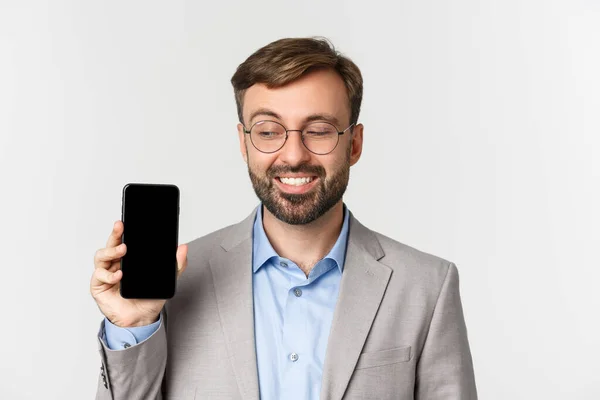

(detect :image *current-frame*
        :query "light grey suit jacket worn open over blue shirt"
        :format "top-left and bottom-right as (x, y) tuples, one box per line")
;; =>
(96, 211), (477, 400)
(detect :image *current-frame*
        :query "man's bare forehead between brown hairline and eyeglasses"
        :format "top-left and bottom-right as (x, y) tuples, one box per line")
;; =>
(243, 69), (350, 124)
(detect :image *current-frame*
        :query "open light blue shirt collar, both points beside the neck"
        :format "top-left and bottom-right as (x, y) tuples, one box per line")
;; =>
(252, 203), (350, 273)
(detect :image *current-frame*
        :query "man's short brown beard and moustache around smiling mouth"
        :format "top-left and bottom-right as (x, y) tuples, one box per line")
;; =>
(248, 148), (352, 225)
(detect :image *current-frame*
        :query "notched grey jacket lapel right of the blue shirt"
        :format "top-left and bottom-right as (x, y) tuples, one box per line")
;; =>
(320, 214), (392, 400)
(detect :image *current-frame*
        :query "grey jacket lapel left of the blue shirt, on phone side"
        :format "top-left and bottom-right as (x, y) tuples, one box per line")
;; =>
(210, 210), (259, 400)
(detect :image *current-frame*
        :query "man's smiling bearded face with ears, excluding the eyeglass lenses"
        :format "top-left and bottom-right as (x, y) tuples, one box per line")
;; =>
(238, 70), (363, 225)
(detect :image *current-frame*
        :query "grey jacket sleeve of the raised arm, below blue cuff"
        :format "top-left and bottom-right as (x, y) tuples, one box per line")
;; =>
(96, 307), (167, 400)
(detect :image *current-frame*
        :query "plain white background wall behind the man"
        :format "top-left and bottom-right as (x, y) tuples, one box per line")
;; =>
(0, 0), (600, 400)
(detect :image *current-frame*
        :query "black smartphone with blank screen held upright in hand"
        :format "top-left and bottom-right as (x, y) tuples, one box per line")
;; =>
(120, 183), (179, 299)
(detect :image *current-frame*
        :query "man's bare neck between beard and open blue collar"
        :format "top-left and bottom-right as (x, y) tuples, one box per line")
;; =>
(263, 200), (344, 277)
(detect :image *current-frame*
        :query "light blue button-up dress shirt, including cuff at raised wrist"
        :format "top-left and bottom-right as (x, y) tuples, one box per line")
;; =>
(104, 204), (349, 400)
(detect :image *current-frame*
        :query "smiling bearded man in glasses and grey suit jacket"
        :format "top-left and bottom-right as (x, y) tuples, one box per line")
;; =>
(91, 39), (477, 400)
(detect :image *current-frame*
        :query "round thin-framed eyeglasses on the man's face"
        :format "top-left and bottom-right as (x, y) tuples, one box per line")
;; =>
(244, 121), (354, 155)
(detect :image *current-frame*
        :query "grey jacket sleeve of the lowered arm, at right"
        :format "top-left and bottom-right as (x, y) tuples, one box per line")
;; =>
(415, 263), (477, 400)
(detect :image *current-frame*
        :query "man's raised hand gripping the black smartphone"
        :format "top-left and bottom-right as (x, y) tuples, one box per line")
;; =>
(90, 221), (188, 327)
